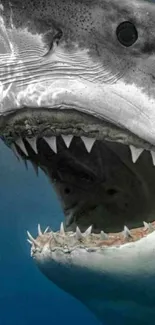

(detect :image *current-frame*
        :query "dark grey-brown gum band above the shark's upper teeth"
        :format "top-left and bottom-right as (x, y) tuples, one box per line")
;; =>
(0, 105), (155, 152)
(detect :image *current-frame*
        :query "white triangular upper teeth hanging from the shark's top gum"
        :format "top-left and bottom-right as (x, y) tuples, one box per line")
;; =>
(12, 135), (155, 165)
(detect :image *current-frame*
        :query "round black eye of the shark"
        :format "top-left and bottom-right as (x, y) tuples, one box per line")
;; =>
(116, 21), (138, 47)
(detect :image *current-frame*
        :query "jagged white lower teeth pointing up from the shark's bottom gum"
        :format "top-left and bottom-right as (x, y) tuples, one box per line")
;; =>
(27, 221), (154, 249)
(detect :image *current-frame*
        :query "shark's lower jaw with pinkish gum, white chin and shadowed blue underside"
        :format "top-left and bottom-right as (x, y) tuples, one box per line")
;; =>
(28, 220), (155, 325)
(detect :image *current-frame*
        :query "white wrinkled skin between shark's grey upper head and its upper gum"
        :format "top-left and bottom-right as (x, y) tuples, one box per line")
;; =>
(0, 31), (155, 149)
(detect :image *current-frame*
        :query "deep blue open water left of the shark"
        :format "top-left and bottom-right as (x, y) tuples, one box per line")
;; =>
(0, 143), (99, 325)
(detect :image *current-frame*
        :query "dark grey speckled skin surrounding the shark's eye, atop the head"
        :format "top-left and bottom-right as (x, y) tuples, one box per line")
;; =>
(1, 0), (155, 98)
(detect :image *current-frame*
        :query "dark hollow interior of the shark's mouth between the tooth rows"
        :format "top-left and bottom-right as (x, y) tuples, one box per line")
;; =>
(10, 135), (155, 238)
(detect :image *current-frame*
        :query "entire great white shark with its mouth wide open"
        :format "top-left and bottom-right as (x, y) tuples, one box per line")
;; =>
(0, 0), (155, 325)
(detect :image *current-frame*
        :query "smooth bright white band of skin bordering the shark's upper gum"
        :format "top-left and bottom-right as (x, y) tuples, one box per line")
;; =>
(0, 67), (155, 149)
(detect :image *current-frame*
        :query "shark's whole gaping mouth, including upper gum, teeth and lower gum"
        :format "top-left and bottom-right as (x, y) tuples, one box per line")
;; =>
(1, 109), (155, 247)
